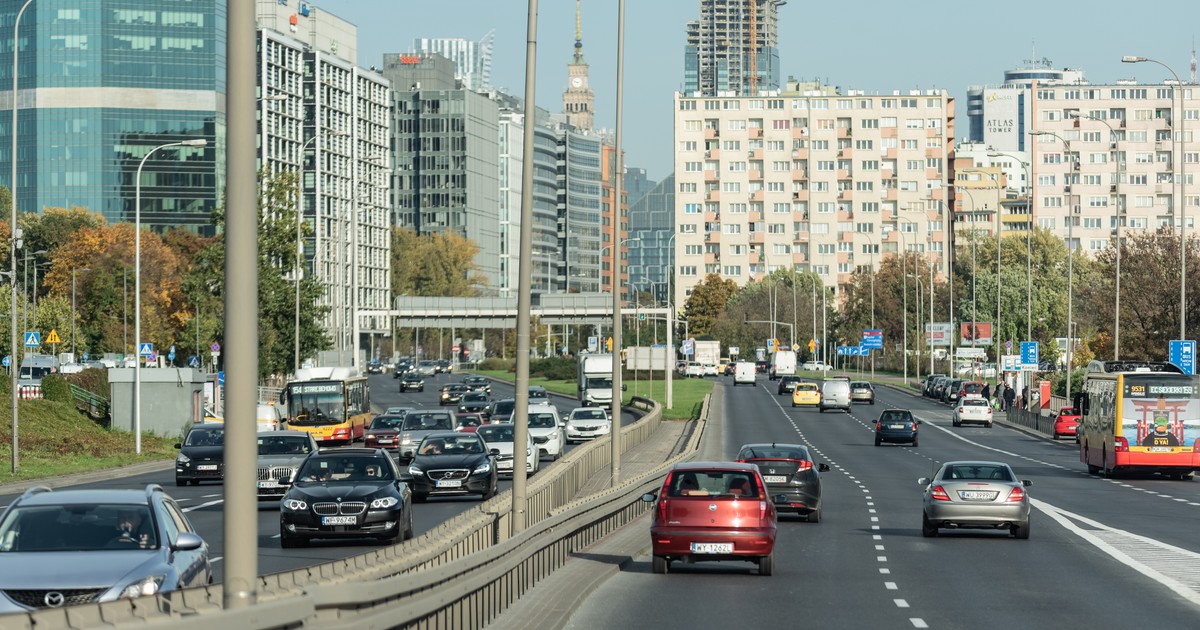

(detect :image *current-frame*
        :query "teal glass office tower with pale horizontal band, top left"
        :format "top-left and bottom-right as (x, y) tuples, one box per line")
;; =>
(0, 0), (227, 234)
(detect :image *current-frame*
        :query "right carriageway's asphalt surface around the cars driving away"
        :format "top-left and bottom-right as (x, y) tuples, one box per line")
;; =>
(568, 377), (1200, 630)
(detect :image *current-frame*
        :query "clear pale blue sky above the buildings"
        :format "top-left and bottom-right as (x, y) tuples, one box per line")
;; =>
(316, 0), (1200, 180)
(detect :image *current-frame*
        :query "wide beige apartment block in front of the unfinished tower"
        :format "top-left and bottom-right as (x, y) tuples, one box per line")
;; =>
(674, 83), (954, 305)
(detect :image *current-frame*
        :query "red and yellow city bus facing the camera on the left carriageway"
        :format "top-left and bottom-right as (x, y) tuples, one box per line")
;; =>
(283, 367), (371, 444)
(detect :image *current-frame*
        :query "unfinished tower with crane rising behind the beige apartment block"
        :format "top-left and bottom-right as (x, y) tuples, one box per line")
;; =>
(683, 0), (786, 96)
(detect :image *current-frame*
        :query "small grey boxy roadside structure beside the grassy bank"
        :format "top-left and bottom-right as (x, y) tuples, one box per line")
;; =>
(108, 367), (208, 436)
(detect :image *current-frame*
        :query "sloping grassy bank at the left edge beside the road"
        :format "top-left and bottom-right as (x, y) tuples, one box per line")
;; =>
(0, 400), (178, 484)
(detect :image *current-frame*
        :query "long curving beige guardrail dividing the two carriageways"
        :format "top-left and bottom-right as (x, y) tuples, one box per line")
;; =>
(14, 397), (709, 630)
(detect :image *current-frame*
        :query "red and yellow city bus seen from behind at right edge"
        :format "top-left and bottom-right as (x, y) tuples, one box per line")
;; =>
(1072, 361), (1200, 479)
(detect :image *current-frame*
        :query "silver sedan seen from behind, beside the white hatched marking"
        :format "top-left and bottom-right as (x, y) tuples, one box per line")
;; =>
(917, 461), (1032, 539)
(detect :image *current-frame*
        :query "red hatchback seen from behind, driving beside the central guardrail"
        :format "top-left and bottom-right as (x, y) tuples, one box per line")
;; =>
(642, 462), (776, 575)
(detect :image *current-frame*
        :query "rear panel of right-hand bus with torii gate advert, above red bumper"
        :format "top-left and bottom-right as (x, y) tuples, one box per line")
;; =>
(1121, 374), (1200, 449)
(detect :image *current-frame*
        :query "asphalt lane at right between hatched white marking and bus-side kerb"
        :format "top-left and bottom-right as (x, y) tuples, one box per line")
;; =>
(873, 392), (1200, 552)
